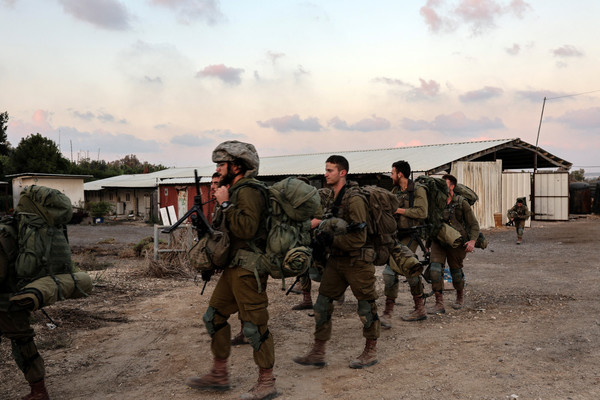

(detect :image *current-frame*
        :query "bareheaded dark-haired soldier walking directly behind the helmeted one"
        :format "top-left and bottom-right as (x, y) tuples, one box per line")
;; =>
(294, 155), (380, 368)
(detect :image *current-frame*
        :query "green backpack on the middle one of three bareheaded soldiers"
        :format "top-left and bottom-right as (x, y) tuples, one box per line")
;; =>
(415, 175), (449, 238)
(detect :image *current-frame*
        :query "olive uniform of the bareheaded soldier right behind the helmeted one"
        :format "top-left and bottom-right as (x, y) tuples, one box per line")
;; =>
(314, 183), (380, 341)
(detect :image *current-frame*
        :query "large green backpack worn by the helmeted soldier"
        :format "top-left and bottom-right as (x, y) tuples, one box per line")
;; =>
(232, 178), (321, 290)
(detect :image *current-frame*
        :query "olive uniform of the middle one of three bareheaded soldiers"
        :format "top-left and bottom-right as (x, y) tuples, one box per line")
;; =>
(383, 180), (427, 300)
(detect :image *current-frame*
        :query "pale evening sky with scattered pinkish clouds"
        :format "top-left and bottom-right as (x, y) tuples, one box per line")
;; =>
(0, 0), (600, 172)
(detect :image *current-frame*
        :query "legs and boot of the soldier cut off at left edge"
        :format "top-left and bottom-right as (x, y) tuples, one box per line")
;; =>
(0, 300), (50, 400)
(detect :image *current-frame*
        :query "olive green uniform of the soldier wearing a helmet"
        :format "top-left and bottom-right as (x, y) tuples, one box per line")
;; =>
(203, 178), (275, 369)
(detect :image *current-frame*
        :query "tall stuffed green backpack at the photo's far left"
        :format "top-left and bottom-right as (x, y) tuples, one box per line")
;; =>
(15, 185), (73, 288)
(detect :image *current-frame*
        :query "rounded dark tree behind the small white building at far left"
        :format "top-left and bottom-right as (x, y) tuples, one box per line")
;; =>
(10, 133), (71, 174)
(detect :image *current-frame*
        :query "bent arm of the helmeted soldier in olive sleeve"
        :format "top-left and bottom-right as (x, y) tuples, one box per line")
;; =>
(225, 187), (265, 240)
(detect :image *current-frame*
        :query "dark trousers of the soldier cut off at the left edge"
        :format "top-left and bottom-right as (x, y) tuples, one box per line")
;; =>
(0, 310), (46, 383)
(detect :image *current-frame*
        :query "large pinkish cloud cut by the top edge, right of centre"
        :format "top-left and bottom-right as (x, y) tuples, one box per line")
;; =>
(420, 0), (531, 35)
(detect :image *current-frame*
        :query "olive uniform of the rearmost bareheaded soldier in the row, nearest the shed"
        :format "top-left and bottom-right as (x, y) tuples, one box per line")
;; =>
(430, 194), (479, 292)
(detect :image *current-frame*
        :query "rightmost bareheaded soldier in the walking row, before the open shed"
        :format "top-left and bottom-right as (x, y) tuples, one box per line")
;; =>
(429, 174), (479, 314)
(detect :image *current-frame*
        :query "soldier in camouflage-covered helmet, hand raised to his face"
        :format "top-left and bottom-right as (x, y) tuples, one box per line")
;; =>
(186, 141), (277, 399)
